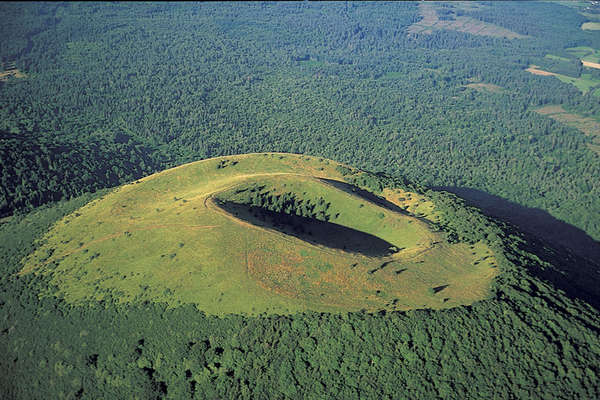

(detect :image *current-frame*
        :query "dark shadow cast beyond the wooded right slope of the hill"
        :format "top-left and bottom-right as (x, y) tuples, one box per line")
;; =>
(435, 187), (600, 309)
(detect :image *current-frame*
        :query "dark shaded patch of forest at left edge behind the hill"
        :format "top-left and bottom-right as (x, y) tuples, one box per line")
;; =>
(0, 131), (164, 216)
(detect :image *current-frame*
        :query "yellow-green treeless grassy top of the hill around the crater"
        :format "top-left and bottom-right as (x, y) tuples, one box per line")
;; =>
(21, 153), (498, 315)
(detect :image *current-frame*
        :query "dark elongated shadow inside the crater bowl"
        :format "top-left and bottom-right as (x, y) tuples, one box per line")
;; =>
(215, 200), (396, 257)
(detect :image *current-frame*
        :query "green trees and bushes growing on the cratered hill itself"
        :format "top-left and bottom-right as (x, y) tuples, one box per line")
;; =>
(0, 155), (600, 399)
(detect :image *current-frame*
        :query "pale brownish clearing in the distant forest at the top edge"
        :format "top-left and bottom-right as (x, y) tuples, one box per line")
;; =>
(408, 3), (525, 39)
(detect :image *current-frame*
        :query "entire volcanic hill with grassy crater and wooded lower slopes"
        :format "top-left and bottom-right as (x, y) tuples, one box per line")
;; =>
(0, 153), (600, 399)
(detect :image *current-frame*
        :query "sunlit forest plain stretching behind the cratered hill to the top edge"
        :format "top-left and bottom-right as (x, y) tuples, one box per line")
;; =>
(0, 2), (600, 239)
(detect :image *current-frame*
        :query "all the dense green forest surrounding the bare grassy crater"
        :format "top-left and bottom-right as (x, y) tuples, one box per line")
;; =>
(0, 2), (600, 399)
